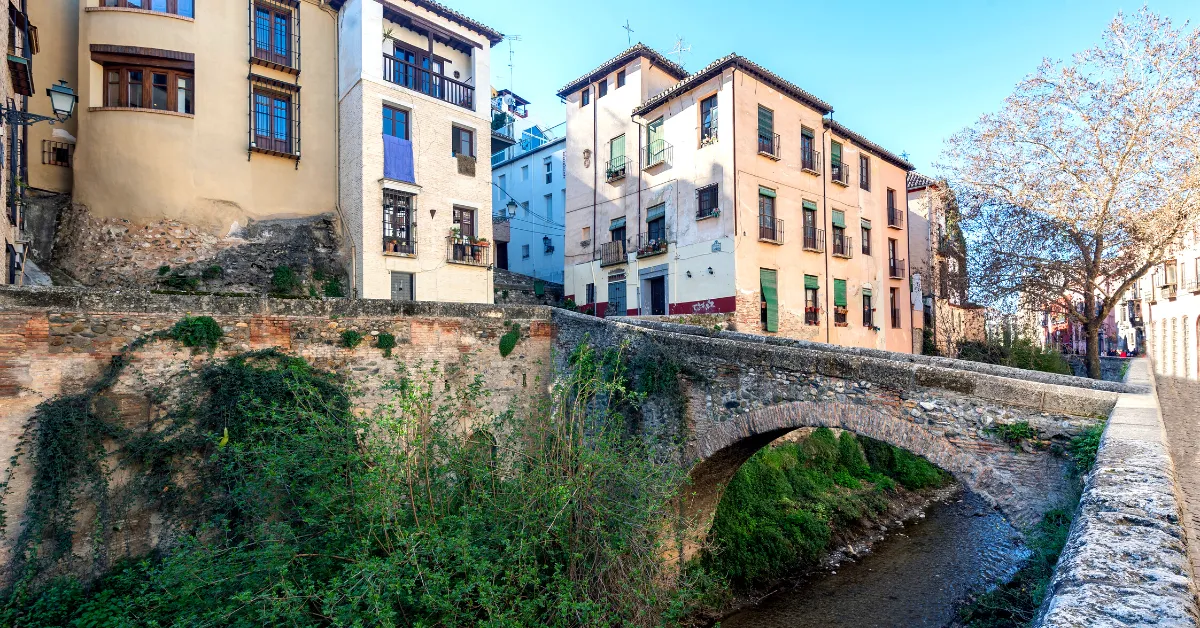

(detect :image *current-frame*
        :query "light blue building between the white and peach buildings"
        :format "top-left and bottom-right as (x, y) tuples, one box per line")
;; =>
(492, 115), (566, 283)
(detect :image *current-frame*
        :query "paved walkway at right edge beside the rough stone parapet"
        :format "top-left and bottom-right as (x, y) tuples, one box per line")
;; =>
(1154, 375), (1200, 583)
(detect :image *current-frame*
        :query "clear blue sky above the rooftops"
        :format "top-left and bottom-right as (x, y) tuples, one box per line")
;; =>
(444, 0), (1200, 172)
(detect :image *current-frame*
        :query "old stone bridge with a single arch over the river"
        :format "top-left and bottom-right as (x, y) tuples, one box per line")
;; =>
(554, 311), (1127, 554)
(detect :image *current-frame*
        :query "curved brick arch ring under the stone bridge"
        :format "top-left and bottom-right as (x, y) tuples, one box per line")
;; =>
(683, 401), (1032, 556)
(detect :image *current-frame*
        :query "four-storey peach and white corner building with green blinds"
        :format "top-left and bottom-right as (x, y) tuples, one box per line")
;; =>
(559, 44), (913, 352)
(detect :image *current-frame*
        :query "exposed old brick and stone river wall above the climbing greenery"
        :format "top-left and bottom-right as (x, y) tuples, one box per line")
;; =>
(0, 288), (552, 578)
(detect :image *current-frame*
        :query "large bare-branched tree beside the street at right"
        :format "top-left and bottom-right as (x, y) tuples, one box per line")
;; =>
(942, 8), (1200, 378)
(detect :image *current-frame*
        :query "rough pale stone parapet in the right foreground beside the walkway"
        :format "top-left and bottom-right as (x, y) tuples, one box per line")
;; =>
(1036, 359), (1200, 627)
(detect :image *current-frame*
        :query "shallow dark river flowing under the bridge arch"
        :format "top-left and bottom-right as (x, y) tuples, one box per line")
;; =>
(720, 492), (1026, 628)
